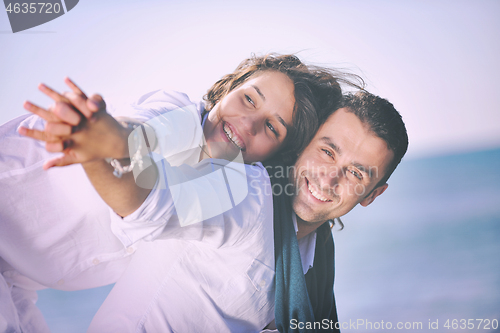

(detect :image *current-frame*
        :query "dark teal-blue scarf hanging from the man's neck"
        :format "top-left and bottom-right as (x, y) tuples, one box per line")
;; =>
(266, 161), (339, 333)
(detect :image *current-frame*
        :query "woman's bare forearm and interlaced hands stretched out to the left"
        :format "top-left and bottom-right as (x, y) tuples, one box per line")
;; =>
(20, 79), (157, 216)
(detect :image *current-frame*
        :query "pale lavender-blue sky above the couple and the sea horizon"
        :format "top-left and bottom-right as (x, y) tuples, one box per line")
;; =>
(0, 0), (500, 157)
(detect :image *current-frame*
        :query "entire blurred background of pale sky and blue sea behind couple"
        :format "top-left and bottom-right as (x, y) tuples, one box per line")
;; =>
(0, 0), (500, 333)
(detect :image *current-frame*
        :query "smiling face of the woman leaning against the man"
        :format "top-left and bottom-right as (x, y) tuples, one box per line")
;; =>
(203, 71), (295, 163)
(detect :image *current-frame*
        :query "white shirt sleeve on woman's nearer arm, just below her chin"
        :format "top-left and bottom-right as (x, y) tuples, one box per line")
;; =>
(111, 159), (270, 246)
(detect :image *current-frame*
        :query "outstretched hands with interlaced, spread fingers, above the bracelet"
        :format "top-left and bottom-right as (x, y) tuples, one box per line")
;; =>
(19, 78), (129, 169)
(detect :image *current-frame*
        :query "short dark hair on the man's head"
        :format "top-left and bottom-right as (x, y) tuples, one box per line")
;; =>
(340, 90), (408, 188)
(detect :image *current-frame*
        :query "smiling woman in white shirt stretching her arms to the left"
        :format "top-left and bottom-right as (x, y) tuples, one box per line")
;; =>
(0, 55), (362, 331)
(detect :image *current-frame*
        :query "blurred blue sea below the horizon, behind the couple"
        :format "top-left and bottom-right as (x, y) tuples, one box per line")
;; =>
(37, 149), (500, 333)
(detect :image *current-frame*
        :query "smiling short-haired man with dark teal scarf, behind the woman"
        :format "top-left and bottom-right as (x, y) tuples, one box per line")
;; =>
(270, 92), (408, 332)
